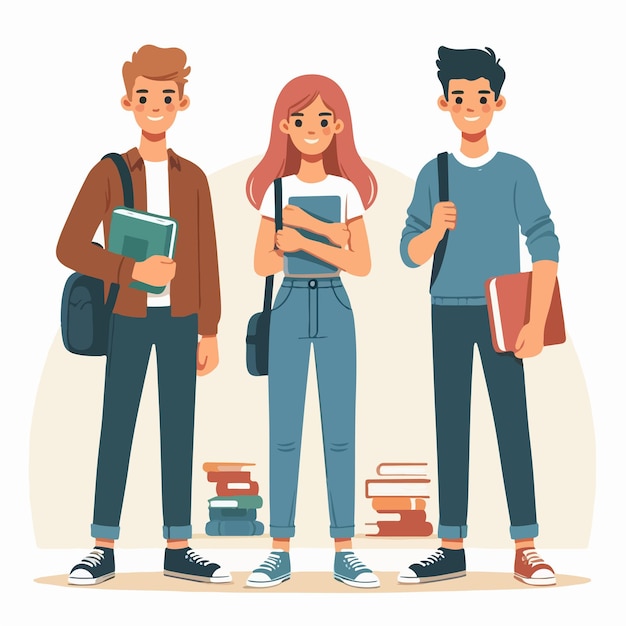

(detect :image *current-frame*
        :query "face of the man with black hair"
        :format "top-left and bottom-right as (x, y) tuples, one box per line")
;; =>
(437, 78), (506, 135)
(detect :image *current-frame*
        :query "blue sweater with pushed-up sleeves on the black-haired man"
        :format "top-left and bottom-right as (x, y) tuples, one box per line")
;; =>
(400, 152), (559, 305)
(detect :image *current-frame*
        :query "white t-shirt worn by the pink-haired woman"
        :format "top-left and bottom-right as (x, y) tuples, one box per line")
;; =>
(259, 174), (365, 222)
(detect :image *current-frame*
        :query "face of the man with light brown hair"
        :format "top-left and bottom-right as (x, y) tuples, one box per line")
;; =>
(122, 76), (189, 135)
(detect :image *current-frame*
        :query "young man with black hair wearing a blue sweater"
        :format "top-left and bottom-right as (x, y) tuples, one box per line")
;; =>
(398, 46), (559, 585)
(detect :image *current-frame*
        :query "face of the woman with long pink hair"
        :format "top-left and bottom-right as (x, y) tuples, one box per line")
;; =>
(279, 96), (343, 156)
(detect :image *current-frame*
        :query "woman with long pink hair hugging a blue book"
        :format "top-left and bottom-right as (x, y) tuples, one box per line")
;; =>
(246, 74), (380, 587)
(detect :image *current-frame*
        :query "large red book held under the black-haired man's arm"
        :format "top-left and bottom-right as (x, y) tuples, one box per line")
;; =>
(485, 272), (565, 352)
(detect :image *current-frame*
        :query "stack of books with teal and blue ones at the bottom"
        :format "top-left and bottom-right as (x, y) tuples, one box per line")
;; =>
(202, 461), (264, 537)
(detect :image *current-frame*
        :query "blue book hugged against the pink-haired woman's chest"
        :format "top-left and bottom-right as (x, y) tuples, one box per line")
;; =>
(283, 196), (341, 276)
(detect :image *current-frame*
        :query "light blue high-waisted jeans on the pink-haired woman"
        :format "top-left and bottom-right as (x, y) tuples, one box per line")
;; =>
(268, 278), (356, 538)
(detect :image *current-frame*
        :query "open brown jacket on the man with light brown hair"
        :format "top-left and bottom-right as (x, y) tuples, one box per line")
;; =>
(57, 148), (221, 335)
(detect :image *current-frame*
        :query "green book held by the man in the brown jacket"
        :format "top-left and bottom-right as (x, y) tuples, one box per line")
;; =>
(108, 207), (178, 293)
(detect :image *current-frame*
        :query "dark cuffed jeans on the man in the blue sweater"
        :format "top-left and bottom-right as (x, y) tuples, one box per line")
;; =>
(432, 305), (539, 539)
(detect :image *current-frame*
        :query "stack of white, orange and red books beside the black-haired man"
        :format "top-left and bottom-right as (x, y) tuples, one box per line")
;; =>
(365, 462), (433, 537)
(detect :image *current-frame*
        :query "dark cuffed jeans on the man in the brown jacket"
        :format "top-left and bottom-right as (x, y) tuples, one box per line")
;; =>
(91, 307), (198, 539)
